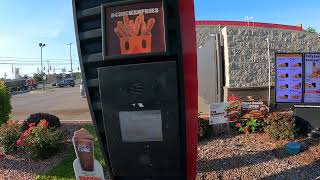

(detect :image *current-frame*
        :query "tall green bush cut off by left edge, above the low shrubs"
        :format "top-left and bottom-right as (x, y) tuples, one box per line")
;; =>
(0, 81), (12, 125)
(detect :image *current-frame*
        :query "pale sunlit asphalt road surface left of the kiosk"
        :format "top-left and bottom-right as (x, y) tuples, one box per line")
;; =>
(11, 87), (91, 120)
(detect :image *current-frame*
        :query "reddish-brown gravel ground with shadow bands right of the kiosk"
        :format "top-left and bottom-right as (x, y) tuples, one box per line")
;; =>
(197, 134), (320, 180)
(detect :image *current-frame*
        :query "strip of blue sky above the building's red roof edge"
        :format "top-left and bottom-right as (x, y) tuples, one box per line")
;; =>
(194, 0), (320, 29)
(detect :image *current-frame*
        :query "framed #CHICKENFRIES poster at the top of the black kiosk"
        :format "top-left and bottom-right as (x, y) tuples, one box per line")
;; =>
(103, 1), (166, 56)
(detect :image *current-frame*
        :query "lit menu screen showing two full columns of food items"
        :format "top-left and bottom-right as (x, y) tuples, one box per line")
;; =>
(276, 54), (302, 103)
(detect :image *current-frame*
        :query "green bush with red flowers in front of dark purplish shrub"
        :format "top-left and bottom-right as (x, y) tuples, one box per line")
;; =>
(22, 126), (64, 159)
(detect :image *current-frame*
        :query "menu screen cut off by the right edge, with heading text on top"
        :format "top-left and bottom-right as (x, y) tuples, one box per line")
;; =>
(304, 54), (320, 103)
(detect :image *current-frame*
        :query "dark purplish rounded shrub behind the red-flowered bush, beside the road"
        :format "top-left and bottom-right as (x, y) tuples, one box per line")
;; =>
(22, 113), (61, 130)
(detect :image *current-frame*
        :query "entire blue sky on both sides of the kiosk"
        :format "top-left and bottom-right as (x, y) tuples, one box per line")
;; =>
(0, 0), (320, 78)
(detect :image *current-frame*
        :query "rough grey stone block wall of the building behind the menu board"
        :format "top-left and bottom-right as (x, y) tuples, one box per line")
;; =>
(222, 27), (320, 87)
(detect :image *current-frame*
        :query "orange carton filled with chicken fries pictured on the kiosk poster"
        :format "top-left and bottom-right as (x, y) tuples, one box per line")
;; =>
(114, 14), (155, 54)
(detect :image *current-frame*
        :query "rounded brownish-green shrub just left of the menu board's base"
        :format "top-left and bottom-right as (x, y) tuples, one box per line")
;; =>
(265, 112), (295, 140)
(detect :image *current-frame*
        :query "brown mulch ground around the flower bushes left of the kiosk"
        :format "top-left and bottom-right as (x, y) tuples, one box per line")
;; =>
(0, 125), (79, 180)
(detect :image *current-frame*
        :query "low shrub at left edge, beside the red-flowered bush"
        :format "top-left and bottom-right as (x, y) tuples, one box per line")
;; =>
(0, 121), (21, 153)
